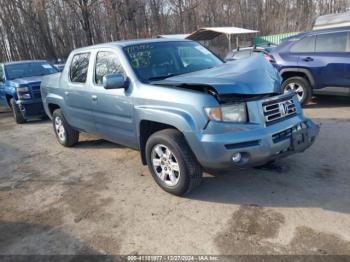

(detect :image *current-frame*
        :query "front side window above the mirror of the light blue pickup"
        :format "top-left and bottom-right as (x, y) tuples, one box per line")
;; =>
(95, 51), (125, 85)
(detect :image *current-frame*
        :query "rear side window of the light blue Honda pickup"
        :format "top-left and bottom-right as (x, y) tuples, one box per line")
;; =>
(69, 53), (90, 83)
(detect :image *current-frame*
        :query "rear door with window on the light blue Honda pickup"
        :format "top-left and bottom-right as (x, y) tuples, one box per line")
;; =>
(63, 52), (96, 133)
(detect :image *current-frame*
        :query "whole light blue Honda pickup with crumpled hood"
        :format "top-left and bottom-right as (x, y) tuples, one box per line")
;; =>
(41, 39), (318, 195)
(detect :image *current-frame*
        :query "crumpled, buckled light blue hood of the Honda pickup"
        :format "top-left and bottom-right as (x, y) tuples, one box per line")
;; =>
(152, 55), (282, 95)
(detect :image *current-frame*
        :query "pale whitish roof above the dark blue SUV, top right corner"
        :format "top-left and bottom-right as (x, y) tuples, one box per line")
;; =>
(313, 12), (350, 30)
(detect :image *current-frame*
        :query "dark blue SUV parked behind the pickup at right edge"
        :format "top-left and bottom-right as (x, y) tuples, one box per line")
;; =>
(271, 27), (350, 104)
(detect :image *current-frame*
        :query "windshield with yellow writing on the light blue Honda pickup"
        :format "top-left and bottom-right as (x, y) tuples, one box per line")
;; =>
(124, 41), (223, 82)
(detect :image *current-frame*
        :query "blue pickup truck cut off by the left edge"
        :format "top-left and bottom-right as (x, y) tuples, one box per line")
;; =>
(0, 61), (57, 124)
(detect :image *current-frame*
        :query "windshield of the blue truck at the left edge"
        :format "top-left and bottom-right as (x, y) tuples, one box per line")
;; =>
(5, 62), (57, 80)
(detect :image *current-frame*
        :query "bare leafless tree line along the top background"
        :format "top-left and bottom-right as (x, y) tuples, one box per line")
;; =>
(0, 0), (350, 61)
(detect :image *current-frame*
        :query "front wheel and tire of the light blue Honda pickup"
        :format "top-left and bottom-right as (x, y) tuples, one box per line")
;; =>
(146, 129), (202, 196)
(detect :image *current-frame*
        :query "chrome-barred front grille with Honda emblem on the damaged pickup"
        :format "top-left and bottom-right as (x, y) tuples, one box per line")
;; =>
(262, 96), (296, 125)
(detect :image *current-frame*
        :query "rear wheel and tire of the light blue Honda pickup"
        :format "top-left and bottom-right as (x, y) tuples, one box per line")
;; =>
(52, 109), (79, 147)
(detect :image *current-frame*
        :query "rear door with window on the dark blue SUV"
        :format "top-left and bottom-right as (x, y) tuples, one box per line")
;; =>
(315, 31), (350, 93)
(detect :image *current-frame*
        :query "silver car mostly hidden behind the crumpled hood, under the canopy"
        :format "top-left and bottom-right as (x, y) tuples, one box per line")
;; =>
(225, 46), (273, 62)
